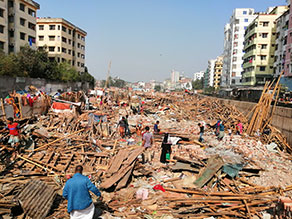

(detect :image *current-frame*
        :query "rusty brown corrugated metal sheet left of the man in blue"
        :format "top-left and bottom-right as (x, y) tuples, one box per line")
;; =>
(15, 180), (56, 219)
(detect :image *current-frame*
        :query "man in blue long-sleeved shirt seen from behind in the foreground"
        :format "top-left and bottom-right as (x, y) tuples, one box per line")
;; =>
(63, 165), (101, 219)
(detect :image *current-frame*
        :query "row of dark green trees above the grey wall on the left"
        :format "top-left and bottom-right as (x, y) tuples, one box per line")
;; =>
(0, 46), (95, 85)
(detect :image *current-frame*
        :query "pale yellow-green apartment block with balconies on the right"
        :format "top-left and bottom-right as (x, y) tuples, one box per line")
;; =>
(242, 6), (288, 86)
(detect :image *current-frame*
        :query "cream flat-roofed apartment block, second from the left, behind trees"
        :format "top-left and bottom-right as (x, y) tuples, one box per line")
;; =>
(37, 18), (87, 72)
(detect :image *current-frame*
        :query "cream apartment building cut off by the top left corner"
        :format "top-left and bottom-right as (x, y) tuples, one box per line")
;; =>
(0, 0), (40, 53)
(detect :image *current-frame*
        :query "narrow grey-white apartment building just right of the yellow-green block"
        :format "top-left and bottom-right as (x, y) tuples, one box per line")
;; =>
(274, 10), (289, 77)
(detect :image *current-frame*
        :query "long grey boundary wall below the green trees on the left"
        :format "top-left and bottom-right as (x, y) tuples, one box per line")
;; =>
(0, 76), (91, 98)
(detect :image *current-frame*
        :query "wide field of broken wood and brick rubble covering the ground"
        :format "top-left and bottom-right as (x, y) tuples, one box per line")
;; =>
(0, 84), (292, 219)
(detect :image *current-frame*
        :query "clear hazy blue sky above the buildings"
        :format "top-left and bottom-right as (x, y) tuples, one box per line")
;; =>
(36, 0), (286, 82)
